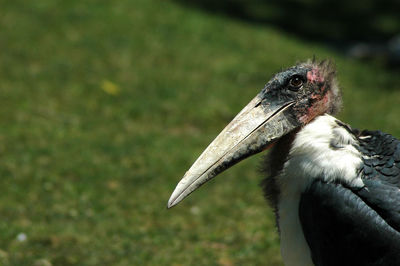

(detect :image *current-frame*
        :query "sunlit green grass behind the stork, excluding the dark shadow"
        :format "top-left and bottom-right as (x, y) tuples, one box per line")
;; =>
(0, 0), (400, 265)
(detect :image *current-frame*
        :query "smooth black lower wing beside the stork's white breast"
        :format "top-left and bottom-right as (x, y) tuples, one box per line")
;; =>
(299, 180), (400, 266)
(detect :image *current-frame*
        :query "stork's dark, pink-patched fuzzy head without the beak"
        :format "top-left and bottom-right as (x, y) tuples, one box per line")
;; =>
(266, 60), (341, 125)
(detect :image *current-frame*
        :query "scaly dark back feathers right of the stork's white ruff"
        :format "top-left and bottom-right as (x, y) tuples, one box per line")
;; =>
(354, 130), (400, 232)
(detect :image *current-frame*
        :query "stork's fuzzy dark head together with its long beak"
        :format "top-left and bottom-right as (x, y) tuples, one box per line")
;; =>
(168, 60), (341, 208)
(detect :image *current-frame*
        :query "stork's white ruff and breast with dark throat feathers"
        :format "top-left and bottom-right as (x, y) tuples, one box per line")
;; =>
(264, 115), (362, 266)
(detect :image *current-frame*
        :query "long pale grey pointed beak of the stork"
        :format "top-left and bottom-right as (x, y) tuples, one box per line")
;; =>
(168, 93), (297, 208)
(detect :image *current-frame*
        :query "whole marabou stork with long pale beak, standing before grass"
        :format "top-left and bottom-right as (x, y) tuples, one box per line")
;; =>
(168, 60), (400, 266)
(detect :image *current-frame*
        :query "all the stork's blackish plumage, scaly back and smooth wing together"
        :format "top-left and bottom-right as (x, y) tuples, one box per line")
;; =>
(299, 127), (400, 266)
